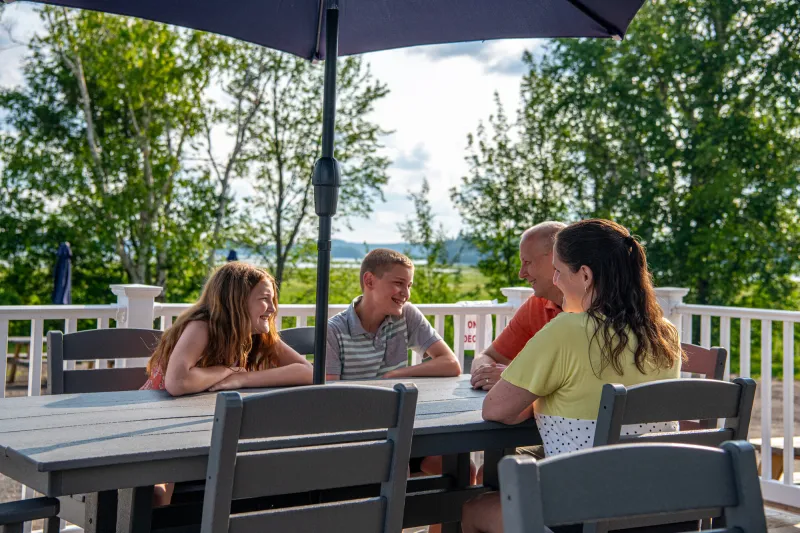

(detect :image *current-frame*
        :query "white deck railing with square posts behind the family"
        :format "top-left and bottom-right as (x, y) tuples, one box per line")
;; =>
(0, 285), (800, 507)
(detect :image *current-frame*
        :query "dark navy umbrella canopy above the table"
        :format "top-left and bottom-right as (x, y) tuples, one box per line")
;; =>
(18, 0), (643, 59)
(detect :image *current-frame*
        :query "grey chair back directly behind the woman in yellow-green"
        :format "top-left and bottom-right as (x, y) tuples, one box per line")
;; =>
(594, 378), (756, 446)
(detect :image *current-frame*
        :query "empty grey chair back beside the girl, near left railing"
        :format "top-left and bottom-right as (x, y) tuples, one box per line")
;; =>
(47, 328), (161, 394)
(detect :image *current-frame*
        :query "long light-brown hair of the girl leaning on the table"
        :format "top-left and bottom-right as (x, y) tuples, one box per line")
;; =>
(147, 261), (279, 374)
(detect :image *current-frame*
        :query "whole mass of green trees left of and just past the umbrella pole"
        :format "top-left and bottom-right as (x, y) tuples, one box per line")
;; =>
(0, 7), (389, 304)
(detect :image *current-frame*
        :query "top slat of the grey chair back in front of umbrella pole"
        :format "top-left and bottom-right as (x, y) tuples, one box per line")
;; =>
(240, 385), (398, 439)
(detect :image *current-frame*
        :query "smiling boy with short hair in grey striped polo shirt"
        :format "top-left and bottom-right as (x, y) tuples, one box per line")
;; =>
(326, 248), (461, 380)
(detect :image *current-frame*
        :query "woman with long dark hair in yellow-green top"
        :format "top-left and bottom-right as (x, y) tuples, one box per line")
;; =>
(462, 219), (682, 533)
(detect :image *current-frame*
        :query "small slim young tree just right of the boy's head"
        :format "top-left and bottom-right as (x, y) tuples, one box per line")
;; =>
(399, 179), (461, 303)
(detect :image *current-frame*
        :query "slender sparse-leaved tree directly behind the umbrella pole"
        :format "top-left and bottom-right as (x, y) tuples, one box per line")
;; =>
(229, 45), (389, 282)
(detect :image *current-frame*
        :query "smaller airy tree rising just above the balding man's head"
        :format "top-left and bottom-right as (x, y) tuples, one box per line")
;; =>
(451, 92), (569, 289)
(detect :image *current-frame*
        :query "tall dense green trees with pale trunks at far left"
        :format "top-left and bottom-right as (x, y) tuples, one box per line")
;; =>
(0, 8), (225, 297)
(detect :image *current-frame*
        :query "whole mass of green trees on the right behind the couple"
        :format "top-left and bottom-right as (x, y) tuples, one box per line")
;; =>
(453, 0), (800, 308)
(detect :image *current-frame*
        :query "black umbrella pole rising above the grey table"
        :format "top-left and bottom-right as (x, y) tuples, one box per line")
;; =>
(311, 6), (341, 385)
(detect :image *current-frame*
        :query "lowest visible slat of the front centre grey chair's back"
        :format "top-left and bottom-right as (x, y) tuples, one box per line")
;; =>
(228, 498), (386, 533)
